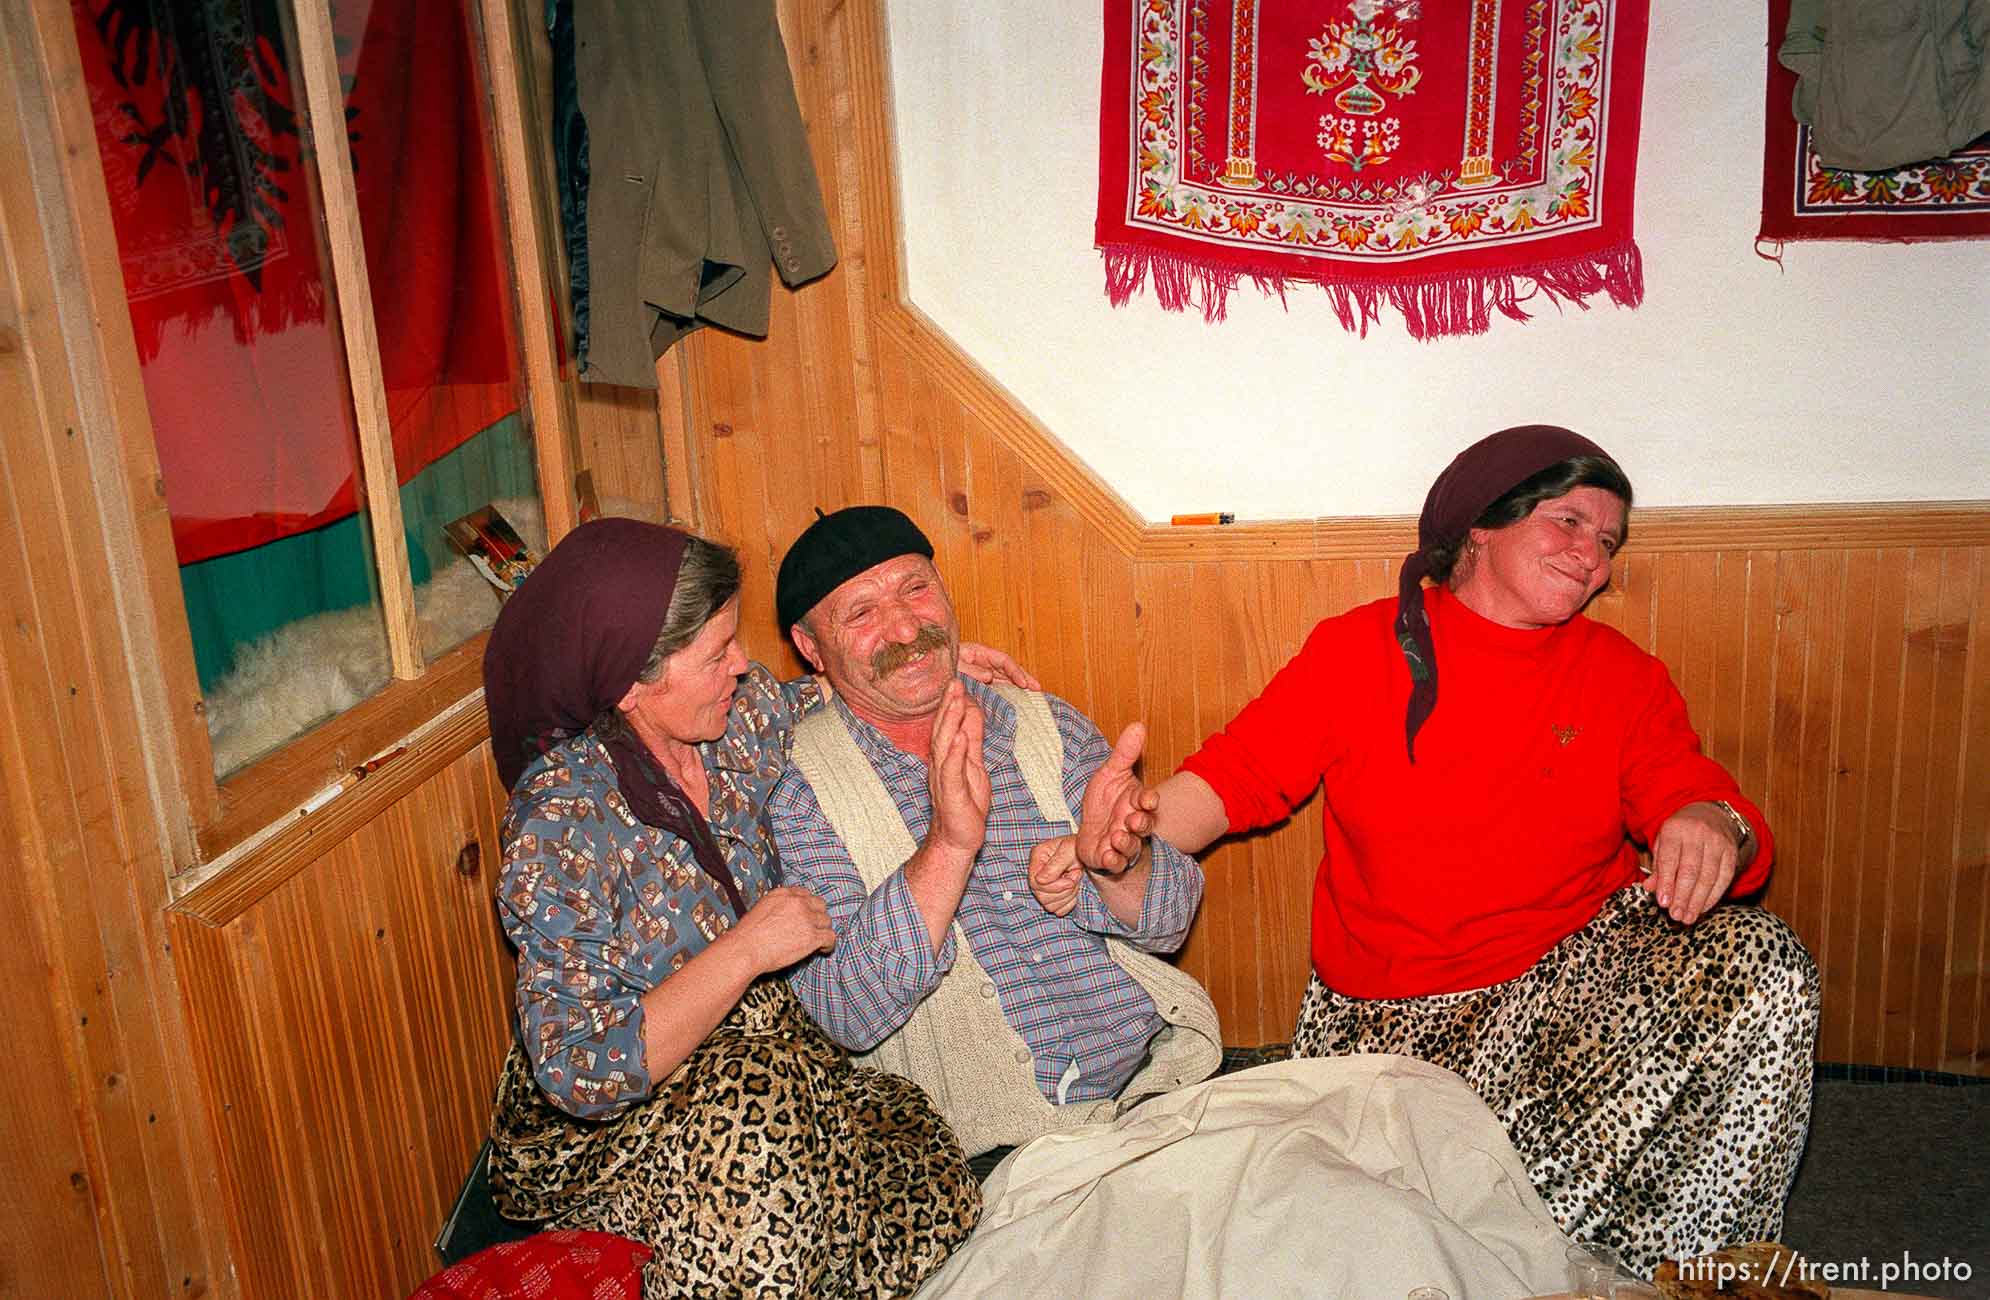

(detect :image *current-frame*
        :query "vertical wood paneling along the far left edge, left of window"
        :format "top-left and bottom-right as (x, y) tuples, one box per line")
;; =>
(0, 0), (231, 1300)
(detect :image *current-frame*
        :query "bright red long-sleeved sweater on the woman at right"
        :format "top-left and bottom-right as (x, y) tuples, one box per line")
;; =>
(1182, 587), (1775, 997)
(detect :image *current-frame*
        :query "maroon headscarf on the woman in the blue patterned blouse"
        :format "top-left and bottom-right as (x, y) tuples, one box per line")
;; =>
(484, 520), (746, 916)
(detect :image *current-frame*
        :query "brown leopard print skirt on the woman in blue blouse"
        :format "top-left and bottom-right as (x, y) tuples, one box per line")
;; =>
(490, 979), (981, 1300)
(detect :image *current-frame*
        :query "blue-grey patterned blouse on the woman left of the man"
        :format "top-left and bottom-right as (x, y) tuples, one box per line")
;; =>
(498, 663), (822, 1119)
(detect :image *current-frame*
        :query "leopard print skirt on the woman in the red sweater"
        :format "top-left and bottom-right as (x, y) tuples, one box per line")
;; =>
(1292, 886), (1819, 1278)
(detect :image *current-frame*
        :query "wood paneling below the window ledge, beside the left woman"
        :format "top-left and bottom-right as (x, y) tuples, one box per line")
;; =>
(171, 736), (513, 1300)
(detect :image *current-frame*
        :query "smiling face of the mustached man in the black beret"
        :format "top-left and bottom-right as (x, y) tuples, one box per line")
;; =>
(794, 555), (961, 723)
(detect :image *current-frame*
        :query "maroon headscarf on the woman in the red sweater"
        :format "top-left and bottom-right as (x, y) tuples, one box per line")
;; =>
(1395, 424), (1614, 762)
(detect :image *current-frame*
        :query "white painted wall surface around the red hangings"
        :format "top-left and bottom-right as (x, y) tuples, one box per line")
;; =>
(888, 0), (1990, 520)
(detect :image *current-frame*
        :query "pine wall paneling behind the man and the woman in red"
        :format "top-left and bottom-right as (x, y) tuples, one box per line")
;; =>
(665, 0), (1990, 1073)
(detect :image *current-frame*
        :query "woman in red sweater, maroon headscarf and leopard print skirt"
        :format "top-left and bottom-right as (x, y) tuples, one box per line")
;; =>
(1106, 426), (1819, 1274)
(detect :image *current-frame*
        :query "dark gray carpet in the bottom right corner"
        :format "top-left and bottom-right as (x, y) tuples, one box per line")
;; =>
(1783, 1065), (1990, 1300)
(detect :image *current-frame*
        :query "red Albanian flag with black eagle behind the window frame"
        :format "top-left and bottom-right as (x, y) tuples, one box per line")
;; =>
(74, 0), (517, 563)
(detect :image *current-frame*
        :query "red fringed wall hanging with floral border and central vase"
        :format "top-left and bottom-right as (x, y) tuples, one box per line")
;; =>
(1096, 0), (1648, 338)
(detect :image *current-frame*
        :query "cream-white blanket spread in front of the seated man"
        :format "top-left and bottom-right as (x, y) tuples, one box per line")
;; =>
(919, 1055), (1568, 1300)
